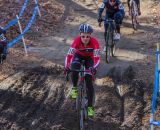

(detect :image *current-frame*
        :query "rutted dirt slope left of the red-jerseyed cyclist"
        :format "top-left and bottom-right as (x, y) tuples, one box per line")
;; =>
(0, 66), (64, 129)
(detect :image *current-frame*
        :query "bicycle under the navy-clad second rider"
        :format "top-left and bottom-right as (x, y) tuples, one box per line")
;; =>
(99, 19), (117, 63)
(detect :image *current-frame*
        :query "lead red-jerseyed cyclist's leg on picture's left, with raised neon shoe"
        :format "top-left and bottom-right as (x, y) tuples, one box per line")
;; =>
(70, 55), (81, 99)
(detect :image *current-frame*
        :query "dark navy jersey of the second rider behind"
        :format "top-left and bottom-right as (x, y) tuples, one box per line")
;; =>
(98, 0), (124, 17)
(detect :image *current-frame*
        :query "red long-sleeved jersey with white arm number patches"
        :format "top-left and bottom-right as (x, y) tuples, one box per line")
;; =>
(65, 36), (100, 68)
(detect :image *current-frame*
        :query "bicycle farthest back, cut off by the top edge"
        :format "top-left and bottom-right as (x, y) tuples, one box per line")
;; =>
(129, 0), (138, 30)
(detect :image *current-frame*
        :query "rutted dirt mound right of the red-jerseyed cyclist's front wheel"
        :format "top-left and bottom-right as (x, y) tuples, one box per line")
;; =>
(97, 66), (146, 130)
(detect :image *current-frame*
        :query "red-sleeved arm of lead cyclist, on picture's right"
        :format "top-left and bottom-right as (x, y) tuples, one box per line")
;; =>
(93, 39), (100, 68)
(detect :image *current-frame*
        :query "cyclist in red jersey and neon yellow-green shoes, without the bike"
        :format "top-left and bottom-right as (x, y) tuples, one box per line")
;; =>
(64, 24), (100, 117)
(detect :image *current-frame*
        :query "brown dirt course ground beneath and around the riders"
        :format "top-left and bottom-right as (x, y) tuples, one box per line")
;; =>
(0, 0), (159, 130)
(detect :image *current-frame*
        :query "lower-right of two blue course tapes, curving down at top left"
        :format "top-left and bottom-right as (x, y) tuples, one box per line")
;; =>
(8, 1), (38, 48)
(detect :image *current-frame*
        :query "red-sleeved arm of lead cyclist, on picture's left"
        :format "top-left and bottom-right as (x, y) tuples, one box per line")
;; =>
(65, 39), (78, 68)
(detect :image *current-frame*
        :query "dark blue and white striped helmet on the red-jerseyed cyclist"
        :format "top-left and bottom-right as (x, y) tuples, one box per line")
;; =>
(79, 24), (93, 33)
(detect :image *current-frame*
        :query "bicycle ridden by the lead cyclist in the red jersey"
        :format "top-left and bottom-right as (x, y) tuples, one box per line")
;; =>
(66, 61), (94, 130)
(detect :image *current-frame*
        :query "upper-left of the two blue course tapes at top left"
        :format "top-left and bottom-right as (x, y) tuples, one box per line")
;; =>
(4, 0), (28, 30)
